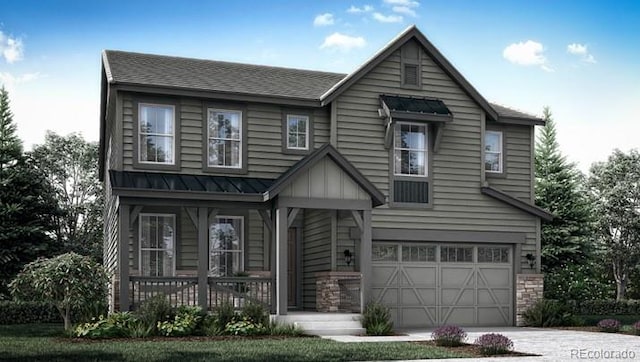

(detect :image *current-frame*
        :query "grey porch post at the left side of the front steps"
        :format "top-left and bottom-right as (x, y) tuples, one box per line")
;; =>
(274, 207), (288, 315)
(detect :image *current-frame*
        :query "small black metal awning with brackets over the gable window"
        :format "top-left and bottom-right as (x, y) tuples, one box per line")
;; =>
(378, 94), (453, 152)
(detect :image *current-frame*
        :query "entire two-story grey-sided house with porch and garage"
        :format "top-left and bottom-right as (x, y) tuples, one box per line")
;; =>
(100, 26), (551, 327)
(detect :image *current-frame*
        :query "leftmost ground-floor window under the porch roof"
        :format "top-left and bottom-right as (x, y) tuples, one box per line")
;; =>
(138, 214), (176, 276)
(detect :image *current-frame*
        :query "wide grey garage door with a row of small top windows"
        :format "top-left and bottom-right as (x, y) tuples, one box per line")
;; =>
(372, 242), (513, 327)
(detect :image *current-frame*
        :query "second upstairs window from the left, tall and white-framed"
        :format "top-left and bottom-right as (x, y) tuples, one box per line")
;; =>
(207, 109), (242, 168)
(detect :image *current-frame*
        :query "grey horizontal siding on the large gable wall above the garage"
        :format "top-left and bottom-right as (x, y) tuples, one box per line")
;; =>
(336, 41), (537, 269)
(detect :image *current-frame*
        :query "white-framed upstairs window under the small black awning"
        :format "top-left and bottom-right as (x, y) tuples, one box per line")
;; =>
(393, 122), (428, 177)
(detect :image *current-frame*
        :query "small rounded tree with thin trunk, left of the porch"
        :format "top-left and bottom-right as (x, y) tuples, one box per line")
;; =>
(9, 253), (108, 330)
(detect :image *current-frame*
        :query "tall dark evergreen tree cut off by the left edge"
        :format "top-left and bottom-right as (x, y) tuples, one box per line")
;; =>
(0, 87), (58, 299)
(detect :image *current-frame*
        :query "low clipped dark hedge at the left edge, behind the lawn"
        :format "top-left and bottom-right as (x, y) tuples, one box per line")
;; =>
(0, 300), (60, 324)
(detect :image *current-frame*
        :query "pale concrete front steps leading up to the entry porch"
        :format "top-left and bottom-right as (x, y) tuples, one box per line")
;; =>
(275, 312), (365, 336)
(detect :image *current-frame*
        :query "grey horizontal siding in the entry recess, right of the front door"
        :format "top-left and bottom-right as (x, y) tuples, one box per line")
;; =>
(302, 209), (334, 310)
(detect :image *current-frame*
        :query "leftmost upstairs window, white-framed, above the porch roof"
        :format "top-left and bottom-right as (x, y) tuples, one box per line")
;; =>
(138, 103), (175, 165)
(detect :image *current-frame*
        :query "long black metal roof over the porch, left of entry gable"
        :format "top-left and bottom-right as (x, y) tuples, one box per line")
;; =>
(109, 170), (275, 202)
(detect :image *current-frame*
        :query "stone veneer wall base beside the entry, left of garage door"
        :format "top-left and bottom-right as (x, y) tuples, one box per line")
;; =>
(316, 271), (361, 313)
